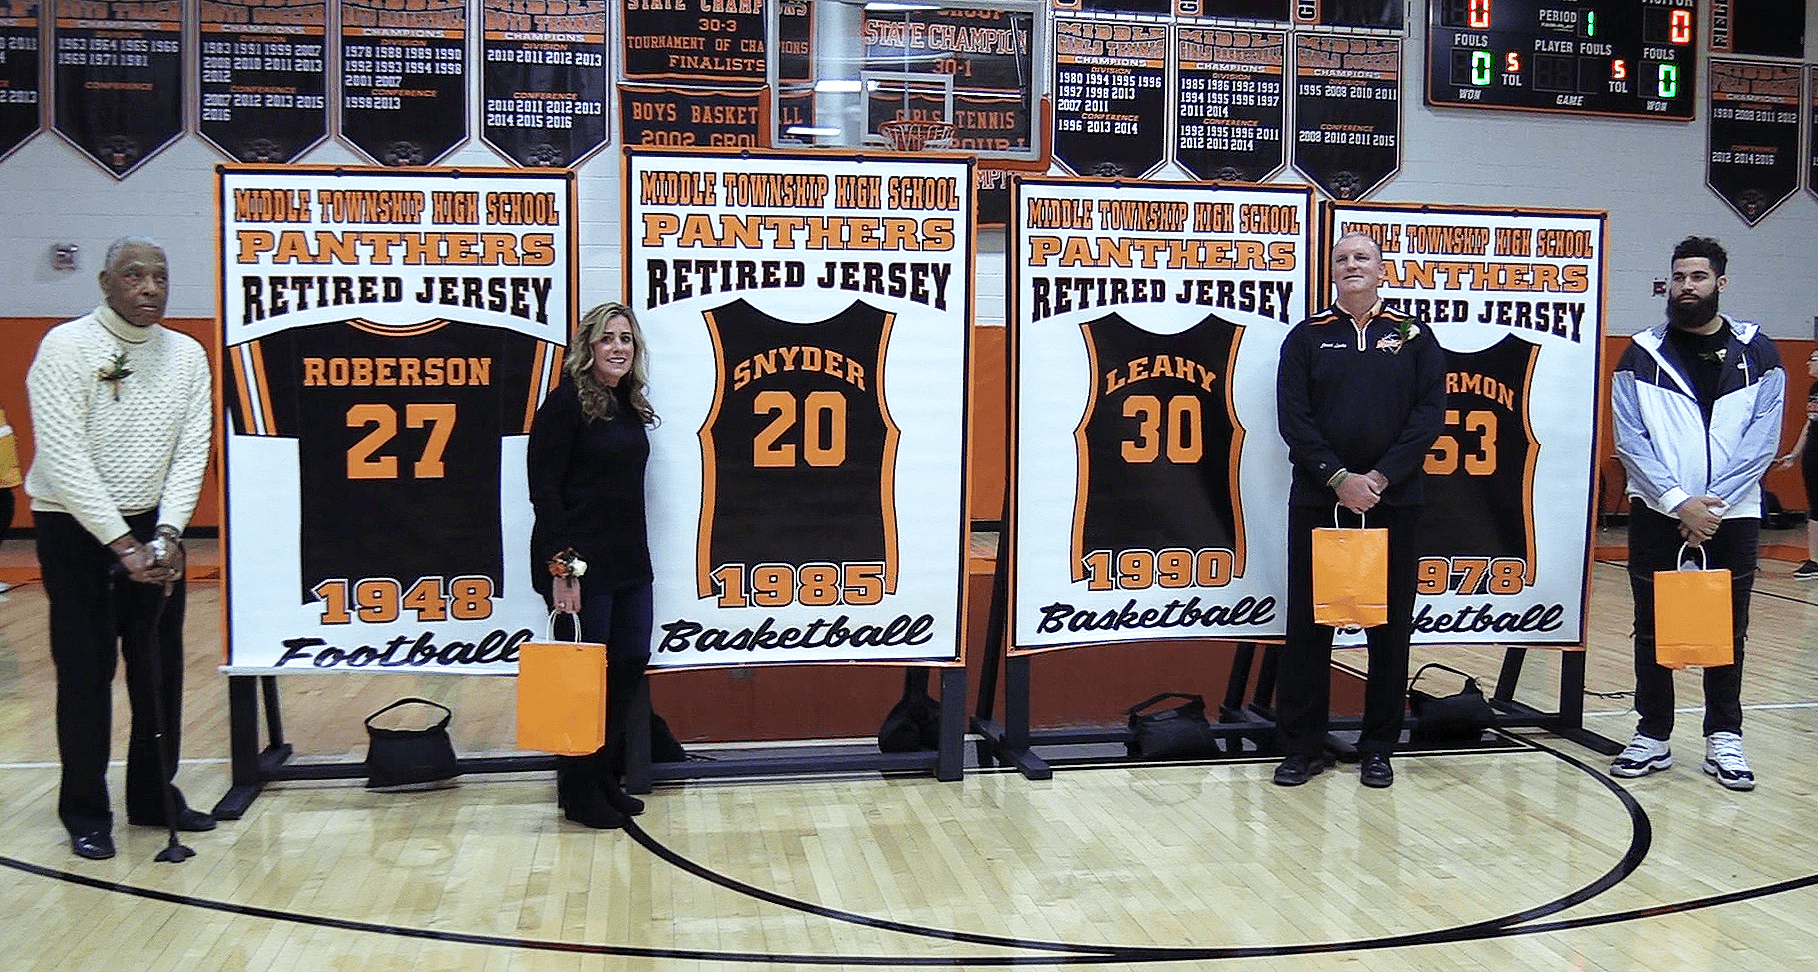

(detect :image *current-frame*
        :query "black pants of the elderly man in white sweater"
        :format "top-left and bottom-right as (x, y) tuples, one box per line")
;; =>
(33, 512), (185, 834)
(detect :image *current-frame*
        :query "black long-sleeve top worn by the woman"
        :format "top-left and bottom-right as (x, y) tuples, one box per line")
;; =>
(527, 380), (651, 596)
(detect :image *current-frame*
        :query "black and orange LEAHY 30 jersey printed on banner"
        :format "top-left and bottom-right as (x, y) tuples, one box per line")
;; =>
(1073, 314), (1244, 581)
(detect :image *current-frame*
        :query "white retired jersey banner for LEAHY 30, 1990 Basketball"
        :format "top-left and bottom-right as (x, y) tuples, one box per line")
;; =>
(1009, 180), (1314, 652)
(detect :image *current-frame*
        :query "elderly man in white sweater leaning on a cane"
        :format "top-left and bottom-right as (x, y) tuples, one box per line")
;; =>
(25, 236), (215, 861)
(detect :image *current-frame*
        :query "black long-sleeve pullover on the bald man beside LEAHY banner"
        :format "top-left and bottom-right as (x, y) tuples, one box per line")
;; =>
(1276, 307), (1445, 507)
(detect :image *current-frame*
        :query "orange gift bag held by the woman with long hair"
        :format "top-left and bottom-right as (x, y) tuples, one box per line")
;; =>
(518, 614), (605, 756)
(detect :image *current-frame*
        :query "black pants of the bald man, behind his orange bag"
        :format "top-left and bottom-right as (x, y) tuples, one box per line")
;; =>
(1274, 503), (1420, 756)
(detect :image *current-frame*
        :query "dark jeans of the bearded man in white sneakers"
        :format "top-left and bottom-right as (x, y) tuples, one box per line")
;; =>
(1629, 500), (1762, 739)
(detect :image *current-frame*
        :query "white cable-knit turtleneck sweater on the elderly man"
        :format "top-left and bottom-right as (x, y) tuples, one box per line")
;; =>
(25, 303), (215, 543)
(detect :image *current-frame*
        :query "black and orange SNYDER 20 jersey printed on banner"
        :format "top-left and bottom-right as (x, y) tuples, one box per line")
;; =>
(696, 300), (898, 598)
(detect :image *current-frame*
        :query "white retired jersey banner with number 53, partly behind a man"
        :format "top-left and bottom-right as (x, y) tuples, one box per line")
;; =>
(1322, 203), (1605, 647)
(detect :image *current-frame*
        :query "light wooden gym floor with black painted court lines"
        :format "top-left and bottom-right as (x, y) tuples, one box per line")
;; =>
(0, 543), (1818, 972)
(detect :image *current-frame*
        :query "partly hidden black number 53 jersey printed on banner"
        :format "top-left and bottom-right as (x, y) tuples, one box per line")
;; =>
(1420, 334), (1540, 583)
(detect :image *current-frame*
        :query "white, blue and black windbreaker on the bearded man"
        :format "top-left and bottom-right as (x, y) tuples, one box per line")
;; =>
(1611, 314), (1787, 520)
